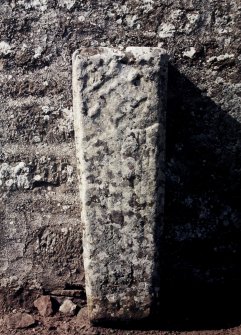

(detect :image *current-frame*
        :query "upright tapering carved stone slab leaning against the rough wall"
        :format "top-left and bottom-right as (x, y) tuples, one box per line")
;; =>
(73, 47), (167, 322)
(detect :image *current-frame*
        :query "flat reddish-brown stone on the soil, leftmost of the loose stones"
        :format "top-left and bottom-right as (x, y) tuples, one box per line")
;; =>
(5, 312), (35, 329)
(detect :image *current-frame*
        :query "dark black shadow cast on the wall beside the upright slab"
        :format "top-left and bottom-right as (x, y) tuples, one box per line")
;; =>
(159, 65), (241, 329)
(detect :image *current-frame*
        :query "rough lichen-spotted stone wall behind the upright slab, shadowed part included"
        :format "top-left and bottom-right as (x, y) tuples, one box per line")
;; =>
(0, 0), (241, 318)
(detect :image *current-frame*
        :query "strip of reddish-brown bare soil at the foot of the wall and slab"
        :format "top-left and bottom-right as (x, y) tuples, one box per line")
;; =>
(0, 308), (241, 335)
